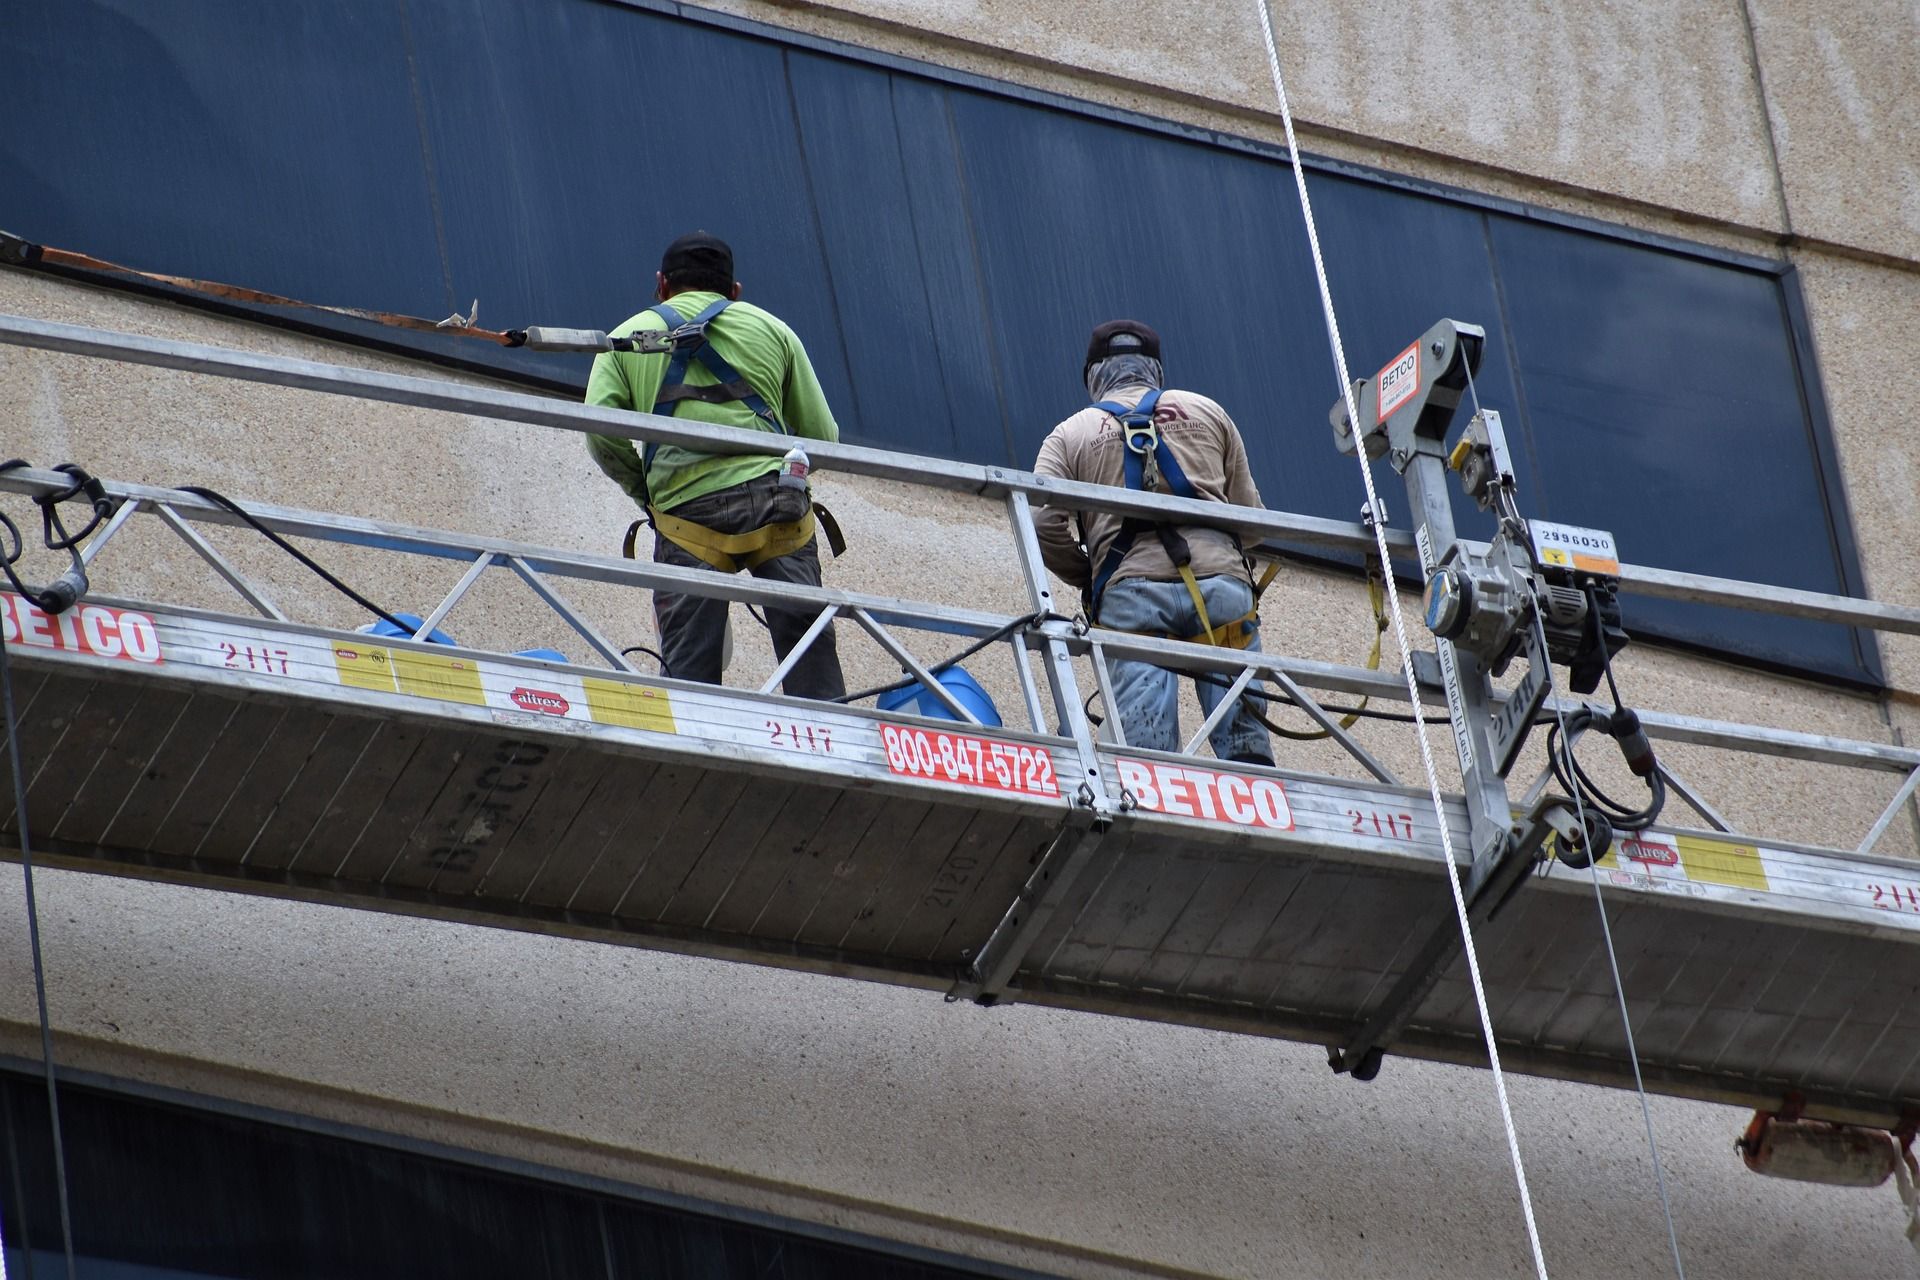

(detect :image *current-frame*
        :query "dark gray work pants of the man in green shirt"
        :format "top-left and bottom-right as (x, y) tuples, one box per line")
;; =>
(653, 472), (847, 699)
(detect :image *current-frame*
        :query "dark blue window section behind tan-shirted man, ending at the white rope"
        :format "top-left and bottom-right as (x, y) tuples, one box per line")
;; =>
(948, 90), (1357, 495)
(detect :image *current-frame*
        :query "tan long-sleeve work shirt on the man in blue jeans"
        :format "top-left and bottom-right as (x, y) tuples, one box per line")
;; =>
(1033, 386), (1261, 591)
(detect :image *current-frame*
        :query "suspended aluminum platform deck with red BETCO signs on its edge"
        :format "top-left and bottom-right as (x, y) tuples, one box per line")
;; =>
(0, 595), (1920, 1125)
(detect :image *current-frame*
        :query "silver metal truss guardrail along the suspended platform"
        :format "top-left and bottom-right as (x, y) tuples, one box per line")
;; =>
(11, 315), (1920, 854)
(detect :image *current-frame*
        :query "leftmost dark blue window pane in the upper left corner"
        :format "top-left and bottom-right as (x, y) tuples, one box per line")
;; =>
(0, 0), (451, 315)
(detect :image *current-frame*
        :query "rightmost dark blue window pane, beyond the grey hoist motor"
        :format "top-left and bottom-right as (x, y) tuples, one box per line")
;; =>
(1494, 217), (1864, 676)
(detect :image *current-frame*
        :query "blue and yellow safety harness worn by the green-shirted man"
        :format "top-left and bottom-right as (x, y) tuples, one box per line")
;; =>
(622, 297), (847, 574)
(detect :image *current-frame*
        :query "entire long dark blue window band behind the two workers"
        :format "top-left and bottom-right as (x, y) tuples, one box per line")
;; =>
(0, 0), (1878, 679)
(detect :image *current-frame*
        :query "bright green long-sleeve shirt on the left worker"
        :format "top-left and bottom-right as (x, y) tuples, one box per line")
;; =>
(586, 292), (839, 510)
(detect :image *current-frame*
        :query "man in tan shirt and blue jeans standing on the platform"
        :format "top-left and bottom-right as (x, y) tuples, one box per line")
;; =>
(1033, 320), (1273, 764)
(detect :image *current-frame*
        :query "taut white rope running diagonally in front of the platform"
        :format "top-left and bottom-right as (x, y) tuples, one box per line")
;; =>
(1256, 0), (1548, 1280)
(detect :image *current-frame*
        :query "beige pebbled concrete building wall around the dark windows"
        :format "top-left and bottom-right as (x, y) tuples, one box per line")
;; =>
(0, 0), (1920, 1280)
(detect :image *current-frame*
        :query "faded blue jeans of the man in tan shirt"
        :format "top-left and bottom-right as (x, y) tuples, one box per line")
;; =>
(1100, 574), (1273, 764)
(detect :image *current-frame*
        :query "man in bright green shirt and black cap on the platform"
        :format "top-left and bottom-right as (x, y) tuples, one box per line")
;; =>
(588, 232), (847, 699)
